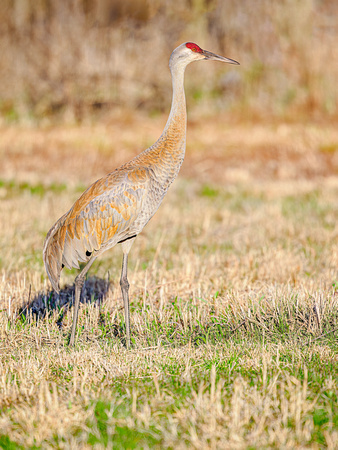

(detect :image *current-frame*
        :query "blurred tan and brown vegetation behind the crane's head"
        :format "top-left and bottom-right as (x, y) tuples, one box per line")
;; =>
(0, 0), (338, 123)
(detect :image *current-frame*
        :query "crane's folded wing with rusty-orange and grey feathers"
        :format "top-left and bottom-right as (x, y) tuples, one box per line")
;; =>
(43, 168), (150, 291)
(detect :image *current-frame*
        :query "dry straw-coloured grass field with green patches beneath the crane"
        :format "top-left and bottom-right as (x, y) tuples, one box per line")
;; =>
(0, 113), (338, 449)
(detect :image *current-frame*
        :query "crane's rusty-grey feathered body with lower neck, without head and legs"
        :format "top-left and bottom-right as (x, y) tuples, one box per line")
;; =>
(44, 90), (186, 291)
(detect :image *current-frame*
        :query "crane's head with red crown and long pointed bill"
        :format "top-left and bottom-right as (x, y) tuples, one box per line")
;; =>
(169, 42), (239, 68)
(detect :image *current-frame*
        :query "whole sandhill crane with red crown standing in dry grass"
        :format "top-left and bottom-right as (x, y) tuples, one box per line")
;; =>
(43, 42), (238, 348)
